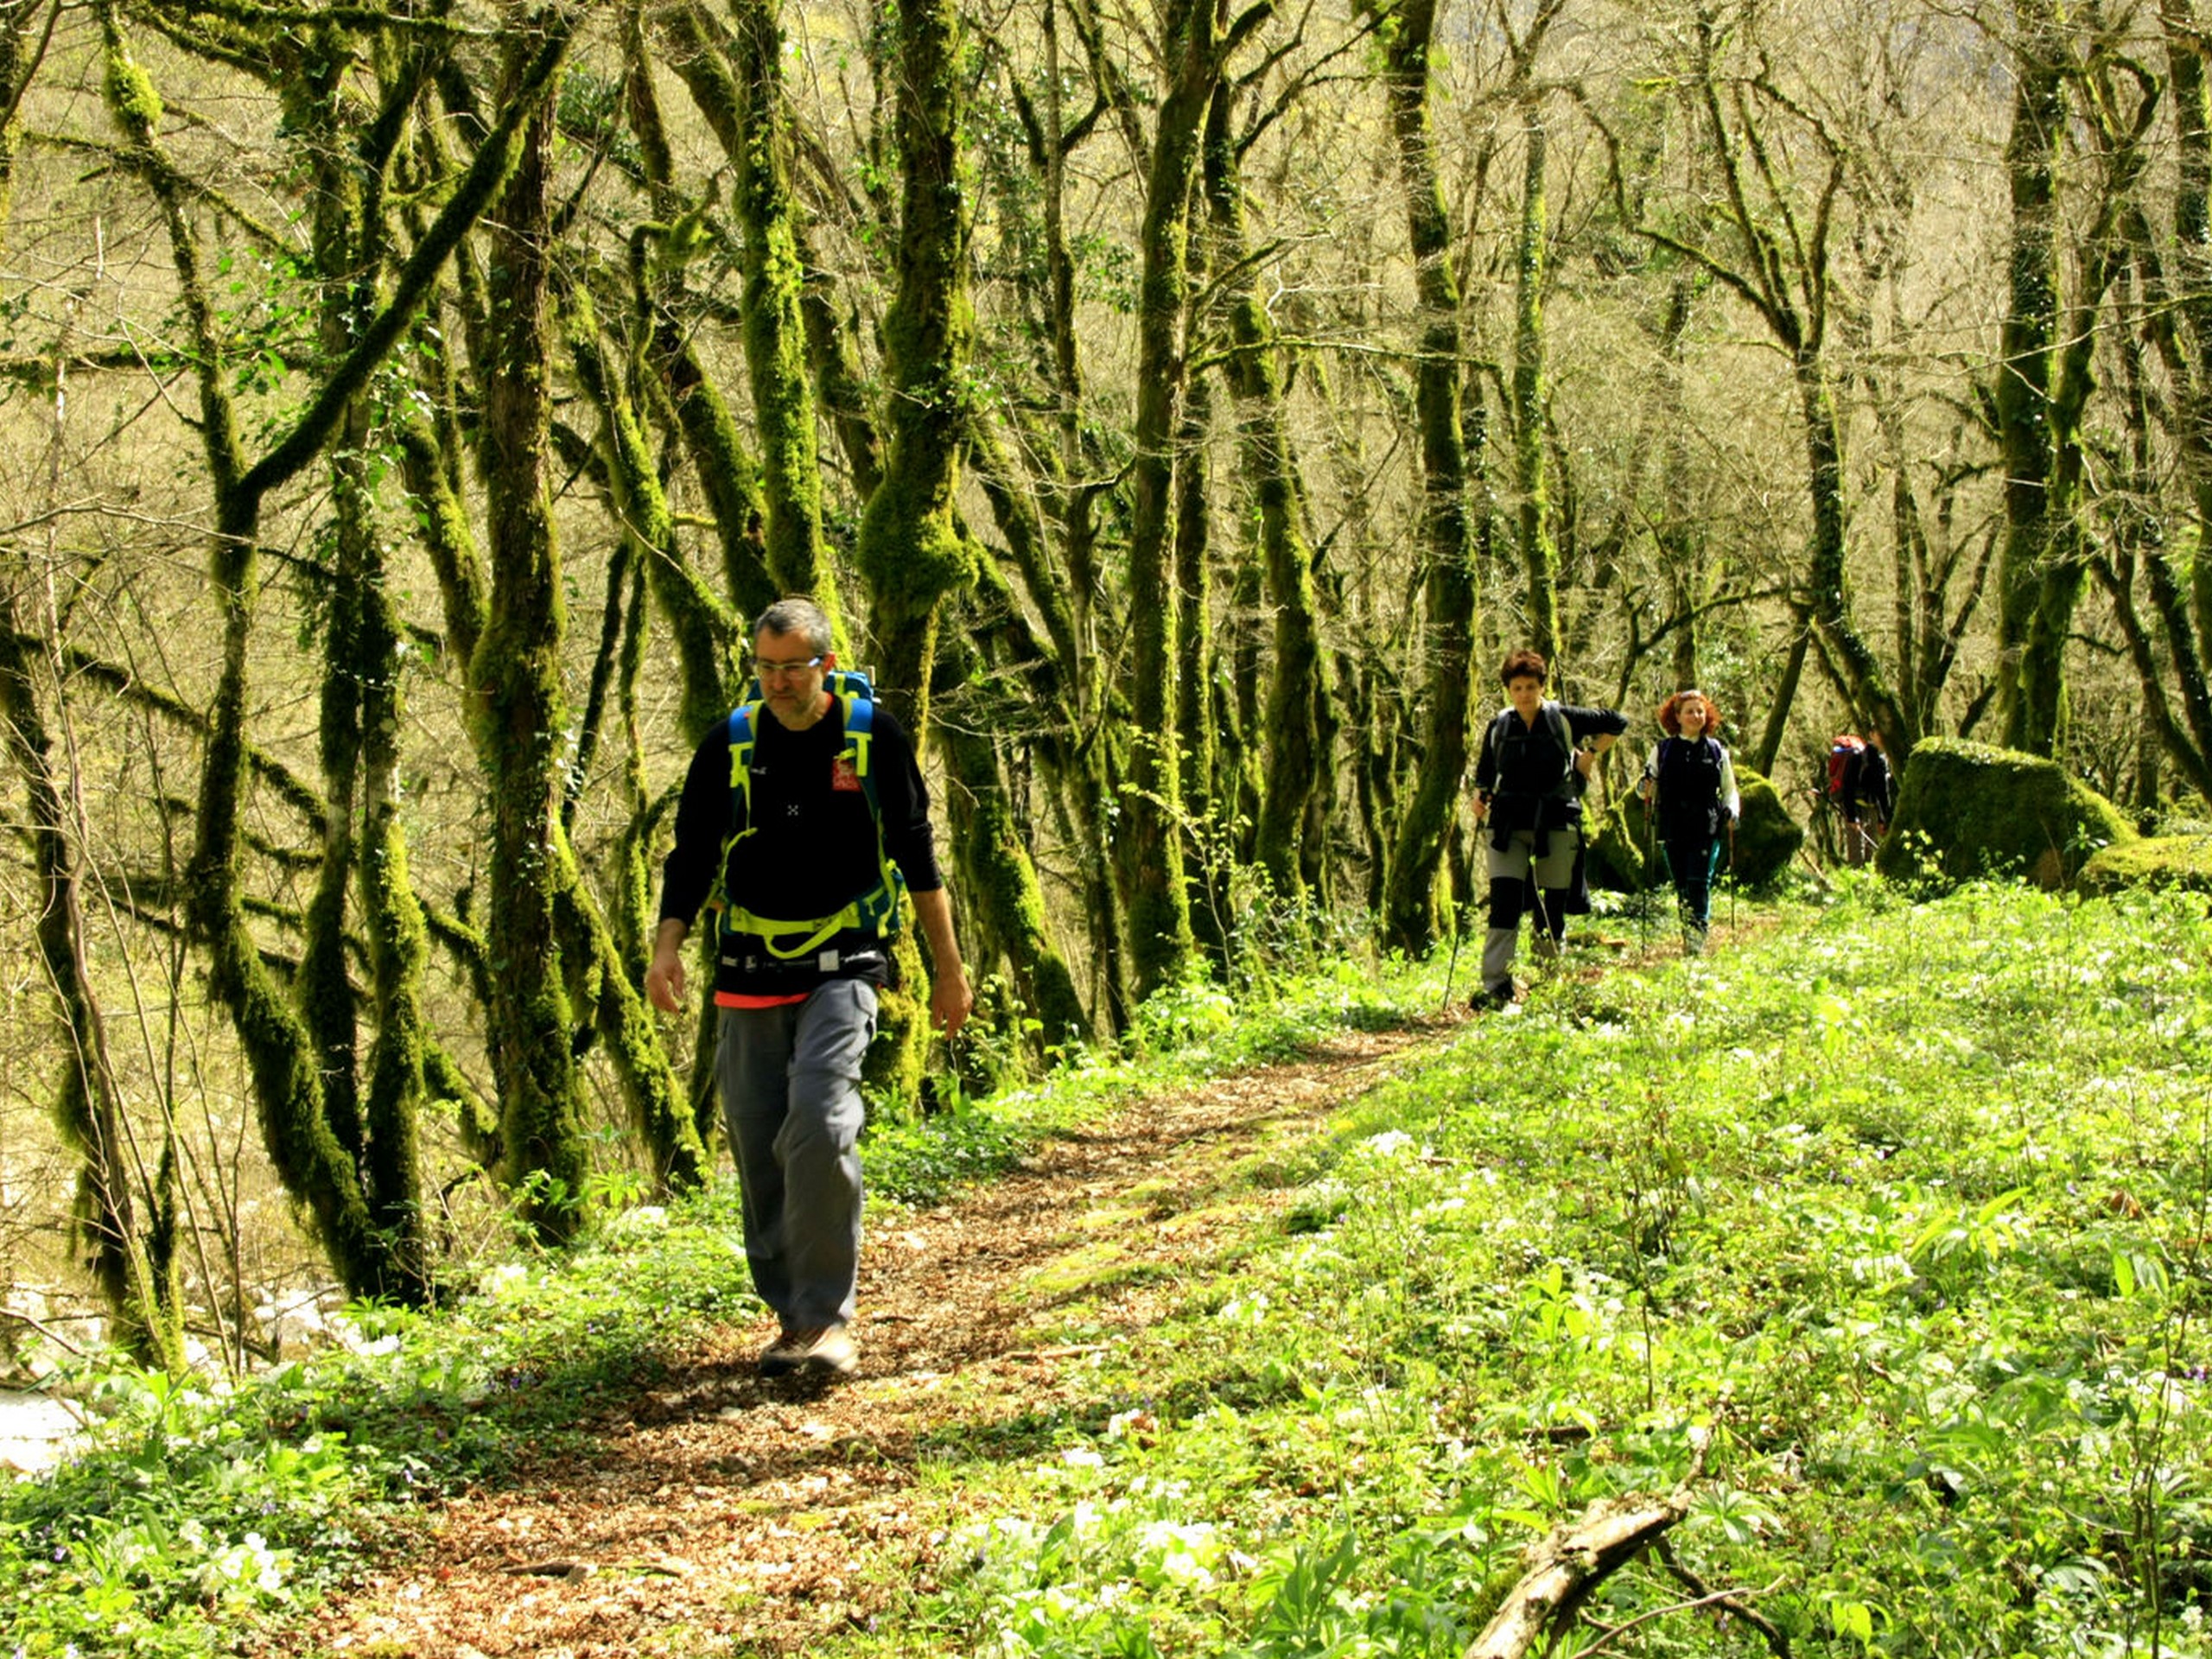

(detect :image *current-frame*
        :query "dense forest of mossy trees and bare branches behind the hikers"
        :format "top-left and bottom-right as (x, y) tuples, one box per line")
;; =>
(0, 0), (2212, 1363)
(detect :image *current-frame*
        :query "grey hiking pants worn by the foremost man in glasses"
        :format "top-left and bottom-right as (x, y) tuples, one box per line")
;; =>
(715, 980), (876, 1330)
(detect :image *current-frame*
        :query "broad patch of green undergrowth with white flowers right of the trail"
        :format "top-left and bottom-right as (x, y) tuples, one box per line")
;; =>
(832, 876), (2212, 1659)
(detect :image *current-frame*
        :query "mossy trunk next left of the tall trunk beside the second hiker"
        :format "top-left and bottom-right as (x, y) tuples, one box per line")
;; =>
(1205, 86), (1332, 902)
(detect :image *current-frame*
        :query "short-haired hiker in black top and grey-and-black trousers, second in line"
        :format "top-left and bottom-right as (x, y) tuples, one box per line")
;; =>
(1473, 651), (1628, 1008)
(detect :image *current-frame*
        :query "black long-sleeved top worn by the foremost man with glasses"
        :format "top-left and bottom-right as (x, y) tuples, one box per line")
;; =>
(661, 703), (944, 995)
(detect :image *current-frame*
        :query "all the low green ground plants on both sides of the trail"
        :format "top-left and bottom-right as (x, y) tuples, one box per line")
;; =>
(0, 898), (2212, 1659)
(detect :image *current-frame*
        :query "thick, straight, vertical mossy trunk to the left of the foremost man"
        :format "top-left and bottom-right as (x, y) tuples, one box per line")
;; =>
(469, 48), (588, 1241)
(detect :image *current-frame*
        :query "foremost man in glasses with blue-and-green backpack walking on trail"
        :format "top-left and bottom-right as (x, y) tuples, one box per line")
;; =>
(646, 600), (976, 1376)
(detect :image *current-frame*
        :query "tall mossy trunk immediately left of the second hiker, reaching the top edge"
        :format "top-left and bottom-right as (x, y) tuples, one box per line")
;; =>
(1382, 0), (1476, 951)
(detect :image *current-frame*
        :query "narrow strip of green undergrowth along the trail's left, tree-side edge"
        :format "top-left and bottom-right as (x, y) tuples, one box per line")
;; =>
(0, 967), (1433, 1659)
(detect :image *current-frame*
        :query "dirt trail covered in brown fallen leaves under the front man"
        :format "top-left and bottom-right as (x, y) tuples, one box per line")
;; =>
(283, 1013), (1466, 1659)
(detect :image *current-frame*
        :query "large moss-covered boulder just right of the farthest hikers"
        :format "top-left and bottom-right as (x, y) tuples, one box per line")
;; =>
(1876, 736), (2137, 892)
